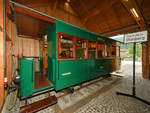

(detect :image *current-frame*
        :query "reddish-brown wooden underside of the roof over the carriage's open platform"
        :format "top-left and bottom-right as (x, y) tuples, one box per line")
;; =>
(16, 12), (50, 39)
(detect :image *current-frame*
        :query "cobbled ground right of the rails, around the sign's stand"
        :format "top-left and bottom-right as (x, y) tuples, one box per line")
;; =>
(76, 61), (150, 113)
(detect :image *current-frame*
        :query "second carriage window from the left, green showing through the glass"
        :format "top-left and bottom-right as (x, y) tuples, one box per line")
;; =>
(76, 39), (86, 59)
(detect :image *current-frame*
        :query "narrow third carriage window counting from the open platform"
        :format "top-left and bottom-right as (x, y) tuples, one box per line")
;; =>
(88, 41), (96, 59)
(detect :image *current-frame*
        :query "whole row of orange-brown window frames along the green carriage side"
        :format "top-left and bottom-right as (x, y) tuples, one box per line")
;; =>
(57, 32), (120, 61)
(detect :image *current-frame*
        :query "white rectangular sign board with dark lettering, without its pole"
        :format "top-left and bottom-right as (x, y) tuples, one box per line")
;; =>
(124, 31), (148, 43)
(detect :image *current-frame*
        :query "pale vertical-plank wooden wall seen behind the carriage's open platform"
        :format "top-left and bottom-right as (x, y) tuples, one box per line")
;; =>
(8, 23), (39, 68)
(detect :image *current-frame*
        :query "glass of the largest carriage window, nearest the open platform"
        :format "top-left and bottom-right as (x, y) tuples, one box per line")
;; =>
(59, 36), (73, 59)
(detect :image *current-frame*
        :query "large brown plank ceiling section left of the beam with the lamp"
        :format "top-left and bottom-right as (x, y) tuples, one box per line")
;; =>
(71, 0), (139, 34)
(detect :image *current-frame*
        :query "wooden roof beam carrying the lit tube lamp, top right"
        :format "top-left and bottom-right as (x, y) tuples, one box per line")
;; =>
(121, 0), (147, 30)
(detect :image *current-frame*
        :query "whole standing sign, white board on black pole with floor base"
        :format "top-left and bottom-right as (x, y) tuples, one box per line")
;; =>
(116, 31), (150, 105)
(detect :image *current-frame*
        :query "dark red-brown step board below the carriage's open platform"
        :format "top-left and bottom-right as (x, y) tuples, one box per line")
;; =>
(20, 96), (57, 113)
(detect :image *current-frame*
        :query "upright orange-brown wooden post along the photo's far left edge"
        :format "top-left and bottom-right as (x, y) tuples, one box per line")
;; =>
(0, 0), (4, 108)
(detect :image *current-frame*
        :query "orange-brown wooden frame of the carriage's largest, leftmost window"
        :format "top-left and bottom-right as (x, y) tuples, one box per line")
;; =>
(57, 32), (76, 61)
